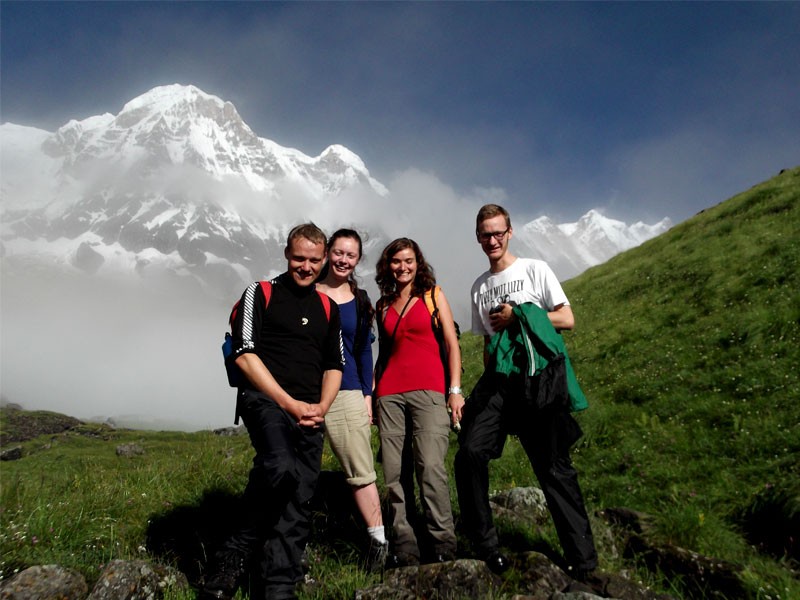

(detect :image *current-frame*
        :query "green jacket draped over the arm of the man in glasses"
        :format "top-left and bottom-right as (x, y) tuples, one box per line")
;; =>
(487, 302), (589, 412)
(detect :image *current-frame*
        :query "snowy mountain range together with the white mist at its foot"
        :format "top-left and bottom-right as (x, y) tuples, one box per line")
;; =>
(0, 85), (669, 429)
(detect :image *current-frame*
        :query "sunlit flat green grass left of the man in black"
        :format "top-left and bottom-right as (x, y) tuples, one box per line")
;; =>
(0, 431), (250, 580)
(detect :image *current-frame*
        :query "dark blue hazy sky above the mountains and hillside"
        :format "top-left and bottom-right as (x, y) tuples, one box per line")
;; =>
(0, 2), (800, 223)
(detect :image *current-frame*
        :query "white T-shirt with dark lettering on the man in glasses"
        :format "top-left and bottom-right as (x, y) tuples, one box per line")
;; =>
(470, 258), (569, 335)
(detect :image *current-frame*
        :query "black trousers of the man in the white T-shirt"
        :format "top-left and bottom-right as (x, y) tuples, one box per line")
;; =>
(455, 373), (597, 569)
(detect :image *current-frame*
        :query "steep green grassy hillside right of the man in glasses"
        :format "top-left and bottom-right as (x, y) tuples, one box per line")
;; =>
(565, 169), (800, 597)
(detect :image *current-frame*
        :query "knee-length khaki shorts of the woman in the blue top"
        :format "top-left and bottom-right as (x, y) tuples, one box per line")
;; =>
(325, 390), (377, 487)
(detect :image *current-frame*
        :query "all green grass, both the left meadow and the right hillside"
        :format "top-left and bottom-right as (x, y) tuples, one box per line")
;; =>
(0, 169), (800, 599)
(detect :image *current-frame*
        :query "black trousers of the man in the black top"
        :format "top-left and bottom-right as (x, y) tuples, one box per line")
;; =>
(222, 390), (324, 600)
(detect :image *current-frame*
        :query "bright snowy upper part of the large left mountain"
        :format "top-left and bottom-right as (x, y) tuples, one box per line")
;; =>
(37, 84), (385, 198)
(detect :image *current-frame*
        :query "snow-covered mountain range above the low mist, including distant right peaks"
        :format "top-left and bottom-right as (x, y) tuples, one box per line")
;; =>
(0, 85), (670, 297)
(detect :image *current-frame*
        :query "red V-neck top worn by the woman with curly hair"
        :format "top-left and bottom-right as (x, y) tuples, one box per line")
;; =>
(376, 298), (444, 397)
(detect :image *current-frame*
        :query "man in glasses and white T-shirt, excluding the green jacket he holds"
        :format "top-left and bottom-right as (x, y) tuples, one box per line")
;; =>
(455, 204), (597, 579)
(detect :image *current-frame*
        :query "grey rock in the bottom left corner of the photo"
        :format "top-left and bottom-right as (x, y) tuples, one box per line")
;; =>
(0, 565), (89, 600)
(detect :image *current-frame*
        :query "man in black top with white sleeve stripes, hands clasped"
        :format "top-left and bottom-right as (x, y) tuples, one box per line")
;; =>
(201, 223), (344, 600)
